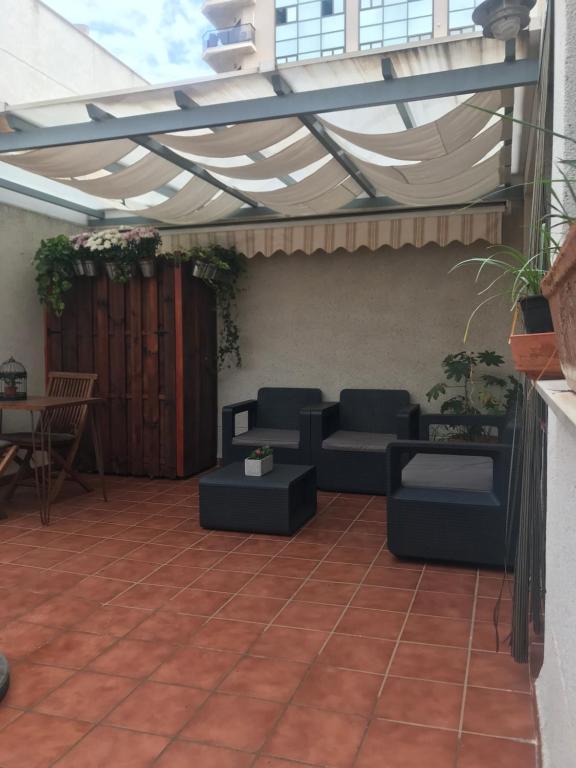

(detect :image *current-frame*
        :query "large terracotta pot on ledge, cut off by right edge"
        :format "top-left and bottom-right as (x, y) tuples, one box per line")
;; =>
(542, 224), (576, 392)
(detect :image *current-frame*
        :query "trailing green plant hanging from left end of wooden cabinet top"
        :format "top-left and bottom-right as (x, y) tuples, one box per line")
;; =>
(33, 235), (77, 317)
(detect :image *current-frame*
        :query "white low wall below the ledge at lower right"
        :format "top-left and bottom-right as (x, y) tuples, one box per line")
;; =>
(536, 395), (576, 768)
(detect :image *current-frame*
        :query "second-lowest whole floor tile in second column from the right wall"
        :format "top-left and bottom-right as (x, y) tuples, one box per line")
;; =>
(390, 643), (466, 684)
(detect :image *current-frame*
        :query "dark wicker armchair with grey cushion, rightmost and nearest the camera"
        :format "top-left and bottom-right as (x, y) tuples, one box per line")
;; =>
(387, 416), (516, 566)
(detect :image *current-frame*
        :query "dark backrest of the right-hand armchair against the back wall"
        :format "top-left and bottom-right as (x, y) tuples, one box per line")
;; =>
(340, 389), (410, 435)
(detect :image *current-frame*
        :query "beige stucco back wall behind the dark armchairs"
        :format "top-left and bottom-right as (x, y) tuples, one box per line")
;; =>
(220, 238), (512, 444)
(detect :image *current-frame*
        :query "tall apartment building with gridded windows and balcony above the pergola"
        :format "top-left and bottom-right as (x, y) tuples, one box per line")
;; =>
(202, 0), (477, 72)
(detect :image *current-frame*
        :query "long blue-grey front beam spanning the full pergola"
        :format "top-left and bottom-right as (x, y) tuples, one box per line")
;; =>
(0, 59), (540, 153)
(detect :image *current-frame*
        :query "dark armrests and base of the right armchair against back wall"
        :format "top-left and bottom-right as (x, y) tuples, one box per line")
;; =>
(310, 392), (420, 496)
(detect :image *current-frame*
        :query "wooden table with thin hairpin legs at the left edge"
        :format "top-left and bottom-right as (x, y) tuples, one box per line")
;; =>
(0, 395), (108, 525)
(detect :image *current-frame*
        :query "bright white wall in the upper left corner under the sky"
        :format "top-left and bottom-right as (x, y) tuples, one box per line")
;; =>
(0, 0), (146, 104)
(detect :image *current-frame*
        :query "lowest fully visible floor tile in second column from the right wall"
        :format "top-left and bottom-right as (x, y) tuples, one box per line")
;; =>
(375, 677), (464, 730)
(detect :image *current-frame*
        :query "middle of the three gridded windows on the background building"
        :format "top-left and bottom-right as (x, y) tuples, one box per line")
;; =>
(360, 0), (434, 50)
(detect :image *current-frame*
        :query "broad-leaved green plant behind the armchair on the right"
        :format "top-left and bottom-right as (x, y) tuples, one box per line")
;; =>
(426, 350), (520, 442)
